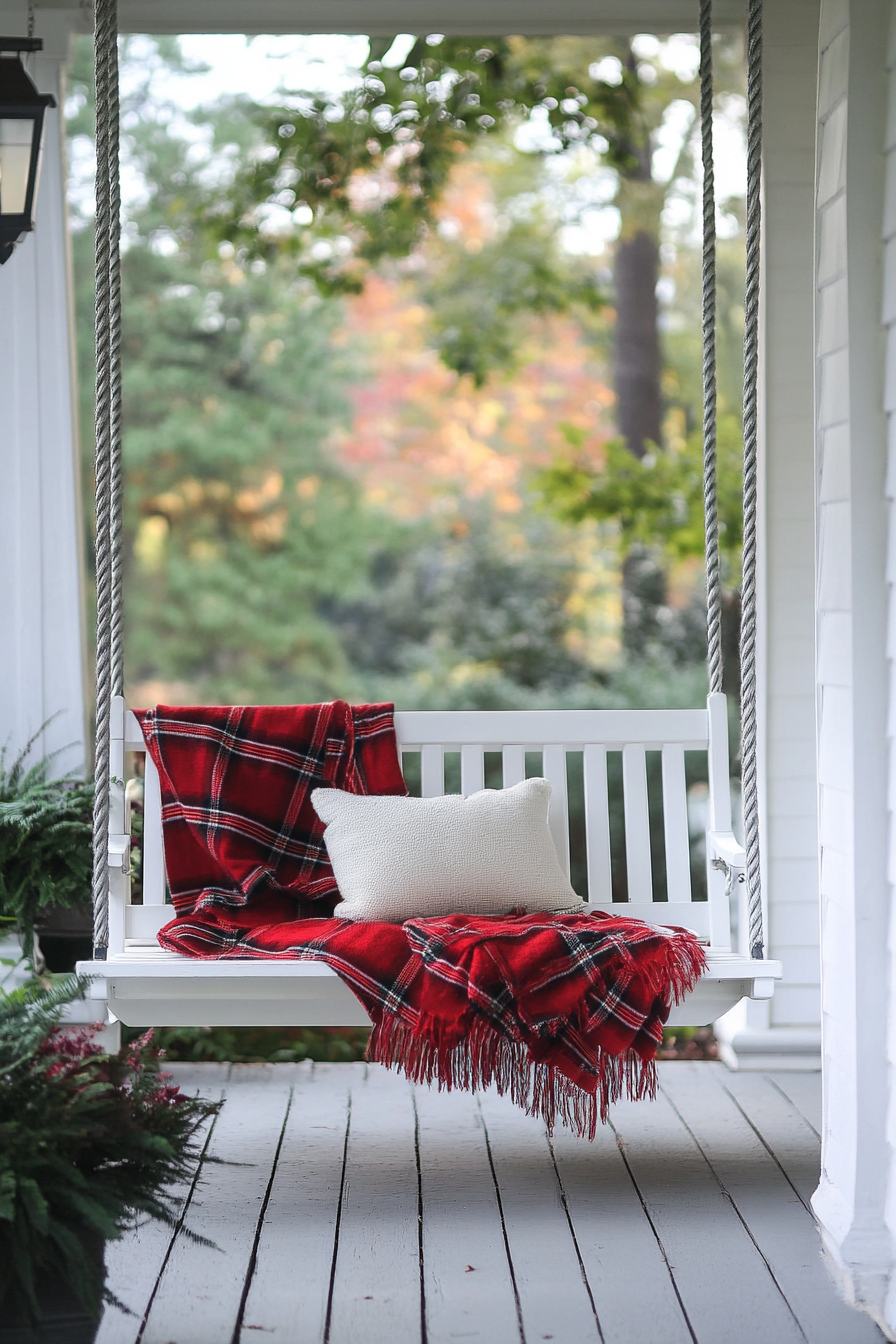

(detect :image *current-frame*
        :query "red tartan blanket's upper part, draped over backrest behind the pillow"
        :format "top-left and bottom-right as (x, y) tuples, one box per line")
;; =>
(137, 700), (407, 919)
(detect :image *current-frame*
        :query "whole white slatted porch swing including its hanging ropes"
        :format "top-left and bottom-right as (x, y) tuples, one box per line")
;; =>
(78, 0), (782, 1027)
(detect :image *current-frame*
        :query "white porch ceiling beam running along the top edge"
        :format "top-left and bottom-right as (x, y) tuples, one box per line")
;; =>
(33, 0), (744, 35)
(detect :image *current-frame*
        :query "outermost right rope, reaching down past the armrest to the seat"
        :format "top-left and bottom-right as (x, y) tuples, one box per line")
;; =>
(740, 0), (763, 960)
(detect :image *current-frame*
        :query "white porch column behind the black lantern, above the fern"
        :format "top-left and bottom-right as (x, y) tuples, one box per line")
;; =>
(0, 13), (87, 773)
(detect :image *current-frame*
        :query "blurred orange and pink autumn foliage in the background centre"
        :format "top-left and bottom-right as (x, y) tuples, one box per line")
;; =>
(333, 276), (613, 520)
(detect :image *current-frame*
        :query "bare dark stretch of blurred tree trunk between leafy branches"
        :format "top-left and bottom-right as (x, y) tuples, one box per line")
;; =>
(614, 228), (662, 457)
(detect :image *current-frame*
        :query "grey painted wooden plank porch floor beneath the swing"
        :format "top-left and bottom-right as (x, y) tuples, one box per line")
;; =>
(98, 1063), (883, 1344)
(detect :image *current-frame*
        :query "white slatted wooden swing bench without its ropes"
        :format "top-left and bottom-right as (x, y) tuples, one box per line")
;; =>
(78, 695), (783, 1027)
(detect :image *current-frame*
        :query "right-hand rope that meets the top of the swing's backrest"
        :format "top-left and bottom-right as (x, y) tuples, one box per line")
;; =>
(700, 0), (723, 691)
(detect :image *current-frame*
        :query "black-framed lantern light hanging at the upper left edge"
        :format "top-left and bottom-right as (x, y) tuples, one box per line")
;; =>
(0, 38), (56, 266)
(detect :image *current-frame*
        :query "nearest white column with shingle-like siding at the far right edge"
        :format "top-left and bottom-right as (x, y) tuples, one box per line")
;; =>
(813, 0), (896, 1337)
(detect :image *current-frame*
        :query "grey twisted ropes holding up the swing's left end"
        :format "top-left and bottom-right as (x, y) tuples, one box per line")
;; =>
(93, 0), (121, 961)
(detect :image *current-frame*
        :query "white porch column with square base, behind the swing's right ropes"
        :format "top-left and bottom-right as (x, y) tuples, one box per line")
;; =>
(716, 0), (821, 1068)
